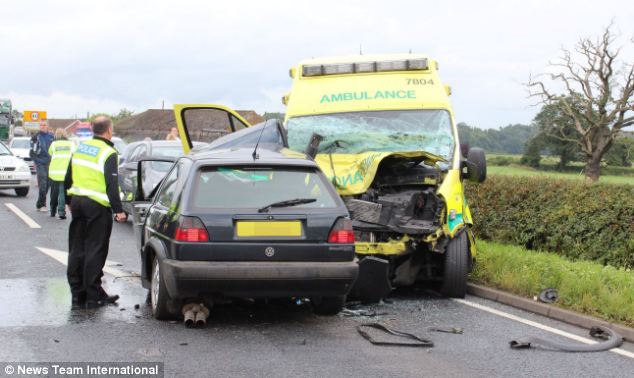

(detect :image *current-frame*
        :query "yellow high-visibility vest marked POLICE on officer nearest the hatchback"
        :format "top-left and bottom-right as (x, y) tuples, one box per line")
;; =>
(68, 139), (117, 207)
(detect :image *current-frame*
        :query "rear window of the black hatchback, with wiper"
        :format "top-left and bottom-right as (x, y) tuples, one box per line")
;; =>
(193, 166), (337, 211)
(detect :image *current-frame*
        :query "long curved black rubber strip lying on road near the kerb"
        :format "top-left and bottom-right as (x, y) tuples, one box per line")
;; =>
(509, 326), (623, 352)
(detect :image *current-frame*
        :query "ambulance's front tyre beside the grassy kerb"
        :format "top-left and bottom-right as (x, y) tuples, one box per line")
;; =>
(440, 232), (470, 298)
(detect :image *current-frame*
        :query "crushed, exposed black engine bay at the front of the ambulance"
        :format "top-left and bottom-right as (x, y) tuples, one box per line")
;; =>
(344, 157), (447, 299)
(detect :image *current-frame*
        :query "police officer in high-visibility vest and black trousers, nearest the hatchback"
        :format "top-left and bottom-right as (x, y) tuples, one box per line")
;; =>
(65, 116), (126, 308)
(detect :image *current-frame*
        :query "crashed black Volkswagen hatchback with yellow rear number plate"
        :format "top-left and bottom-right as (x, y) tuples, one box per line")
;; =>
(134, 148), (358, 319)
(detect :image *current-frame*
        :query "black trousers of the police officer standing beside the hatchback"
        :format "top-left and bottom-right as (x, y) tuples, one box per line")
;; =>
(66, 196), (112, 301)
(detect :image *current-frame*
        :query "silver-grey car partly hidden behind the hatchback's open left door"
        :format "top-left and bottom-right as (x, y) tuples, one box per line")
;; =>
(119, 140), (198, 214)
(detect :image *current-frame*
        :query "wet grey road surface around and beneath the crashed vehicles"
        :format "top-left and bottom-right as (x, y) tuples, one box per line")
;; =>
(0, 182), (634, 377)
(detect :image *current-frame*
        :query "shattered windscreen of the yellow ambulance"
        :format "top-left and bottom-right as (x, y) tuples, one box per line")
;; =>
(286, 110), (454, 160)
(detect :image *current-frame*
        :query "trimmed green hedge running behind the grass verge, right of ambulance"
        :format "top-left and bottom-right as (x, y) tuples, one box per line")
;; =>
(466, 176), (634, 267)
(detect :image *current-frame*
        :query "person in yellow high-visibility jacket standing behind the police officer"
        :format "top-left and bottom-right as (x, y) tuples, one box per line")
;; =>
(48, 129), (75, 219)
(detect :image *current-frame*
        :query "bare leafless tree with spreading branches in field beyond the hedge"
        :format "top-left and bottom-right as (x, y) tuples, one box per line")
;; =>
(527, 24), (634, 182)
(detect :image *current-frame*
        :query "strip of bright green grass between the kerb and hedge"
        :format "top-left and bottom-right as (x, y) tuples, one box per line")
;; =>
(471, 240), (634, 327)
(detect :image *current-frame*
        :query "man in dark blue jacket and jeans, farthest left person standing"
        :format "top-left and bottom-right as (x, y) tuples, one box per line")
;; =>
(29, 120), (53, 213)
